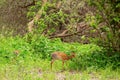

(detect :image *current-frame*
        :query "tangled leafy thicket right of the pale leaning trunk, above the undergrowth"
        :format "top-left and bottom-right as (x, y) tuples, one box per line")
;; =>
(27, 0), (120, 52)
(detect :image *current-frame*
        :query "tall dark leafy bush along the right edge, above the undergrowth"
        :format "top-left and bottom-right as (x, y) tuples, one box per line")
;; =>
(86, 0), (120, 53)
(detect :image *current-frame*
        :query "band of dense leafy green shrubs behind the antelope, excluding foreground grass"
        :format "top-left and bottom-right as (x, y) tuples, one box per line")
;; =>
(0, 35), (120, 70)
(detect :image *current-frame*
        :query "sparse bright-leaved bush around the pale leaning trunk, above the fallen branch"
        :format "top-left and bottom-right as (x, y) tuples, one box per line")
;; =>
(27, 0), (81, 36)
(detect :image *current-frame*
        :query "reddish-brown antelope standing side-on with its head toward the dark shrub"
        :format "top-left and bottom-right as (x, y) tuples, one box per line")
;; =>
(51, 52), (75, 69)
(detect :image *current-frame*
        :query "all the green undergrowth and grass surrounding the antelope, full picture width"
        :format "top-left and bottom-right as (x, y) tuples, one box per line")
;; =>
(0, 35), (120, 80)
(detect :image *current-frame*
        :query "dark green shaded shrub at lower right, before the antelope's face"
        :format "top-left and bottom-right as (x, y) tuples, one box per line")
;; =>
(71, 49), (120, 69)
